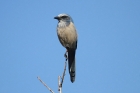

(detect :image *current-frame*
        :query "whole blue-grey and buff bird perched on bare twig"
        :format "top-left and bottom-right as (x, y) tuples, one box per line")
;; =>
(54, 13), (78, 83)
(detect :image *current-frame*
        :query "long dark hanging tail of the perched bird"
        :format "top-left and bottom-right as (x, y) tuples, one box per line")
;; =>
(68, 49), (76, 83)
